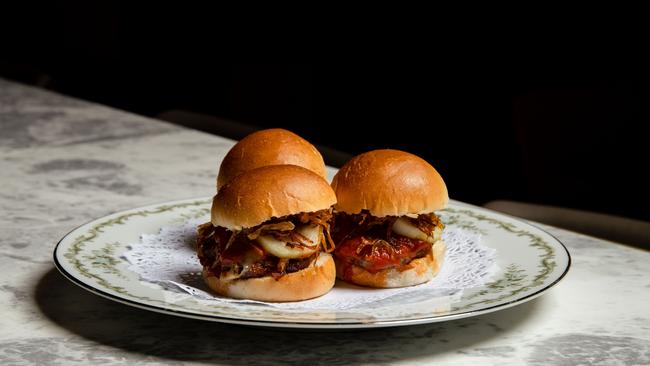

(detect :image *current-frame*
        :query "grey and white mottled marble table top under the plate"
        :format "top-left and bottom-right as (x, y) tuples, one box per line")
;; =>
(0, 79), (650, 365)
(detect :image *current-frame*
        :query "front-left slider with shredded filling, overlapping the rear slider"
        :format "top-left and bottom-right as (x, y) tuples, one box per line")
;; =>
(197, 165), (336, 301)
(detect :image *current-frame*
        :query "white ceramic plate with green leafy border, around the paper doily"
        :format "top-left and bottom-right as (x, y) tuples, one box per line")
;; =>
(54, 198), (571, 329)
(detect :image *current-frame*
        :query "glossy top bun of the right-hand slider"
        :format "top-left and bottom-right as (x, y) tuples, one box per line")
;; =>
(332, 150), (449, 217)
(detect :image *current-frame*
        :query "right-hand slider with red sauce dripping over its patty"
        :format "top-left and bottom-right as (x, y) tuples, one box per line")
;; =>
(332, 150), (449, 287)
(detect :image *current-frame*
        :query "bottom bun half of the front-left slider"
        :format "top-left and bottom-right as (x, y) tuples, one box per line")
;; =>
(203, 253), (336, 301)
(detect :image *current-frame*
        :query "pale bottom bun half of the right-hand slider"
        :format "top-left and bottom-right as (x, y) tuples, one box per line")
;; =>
(335, 240), (446, 288)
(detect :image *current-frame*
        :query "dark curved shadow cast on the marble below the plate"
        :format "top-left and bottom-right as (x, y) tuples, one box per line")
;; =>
(35, 269), (540, 365)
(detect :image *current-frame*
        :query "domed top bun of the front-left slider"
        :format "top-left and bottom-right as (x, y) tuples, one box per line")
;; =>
(211, 165), (336, 230)
